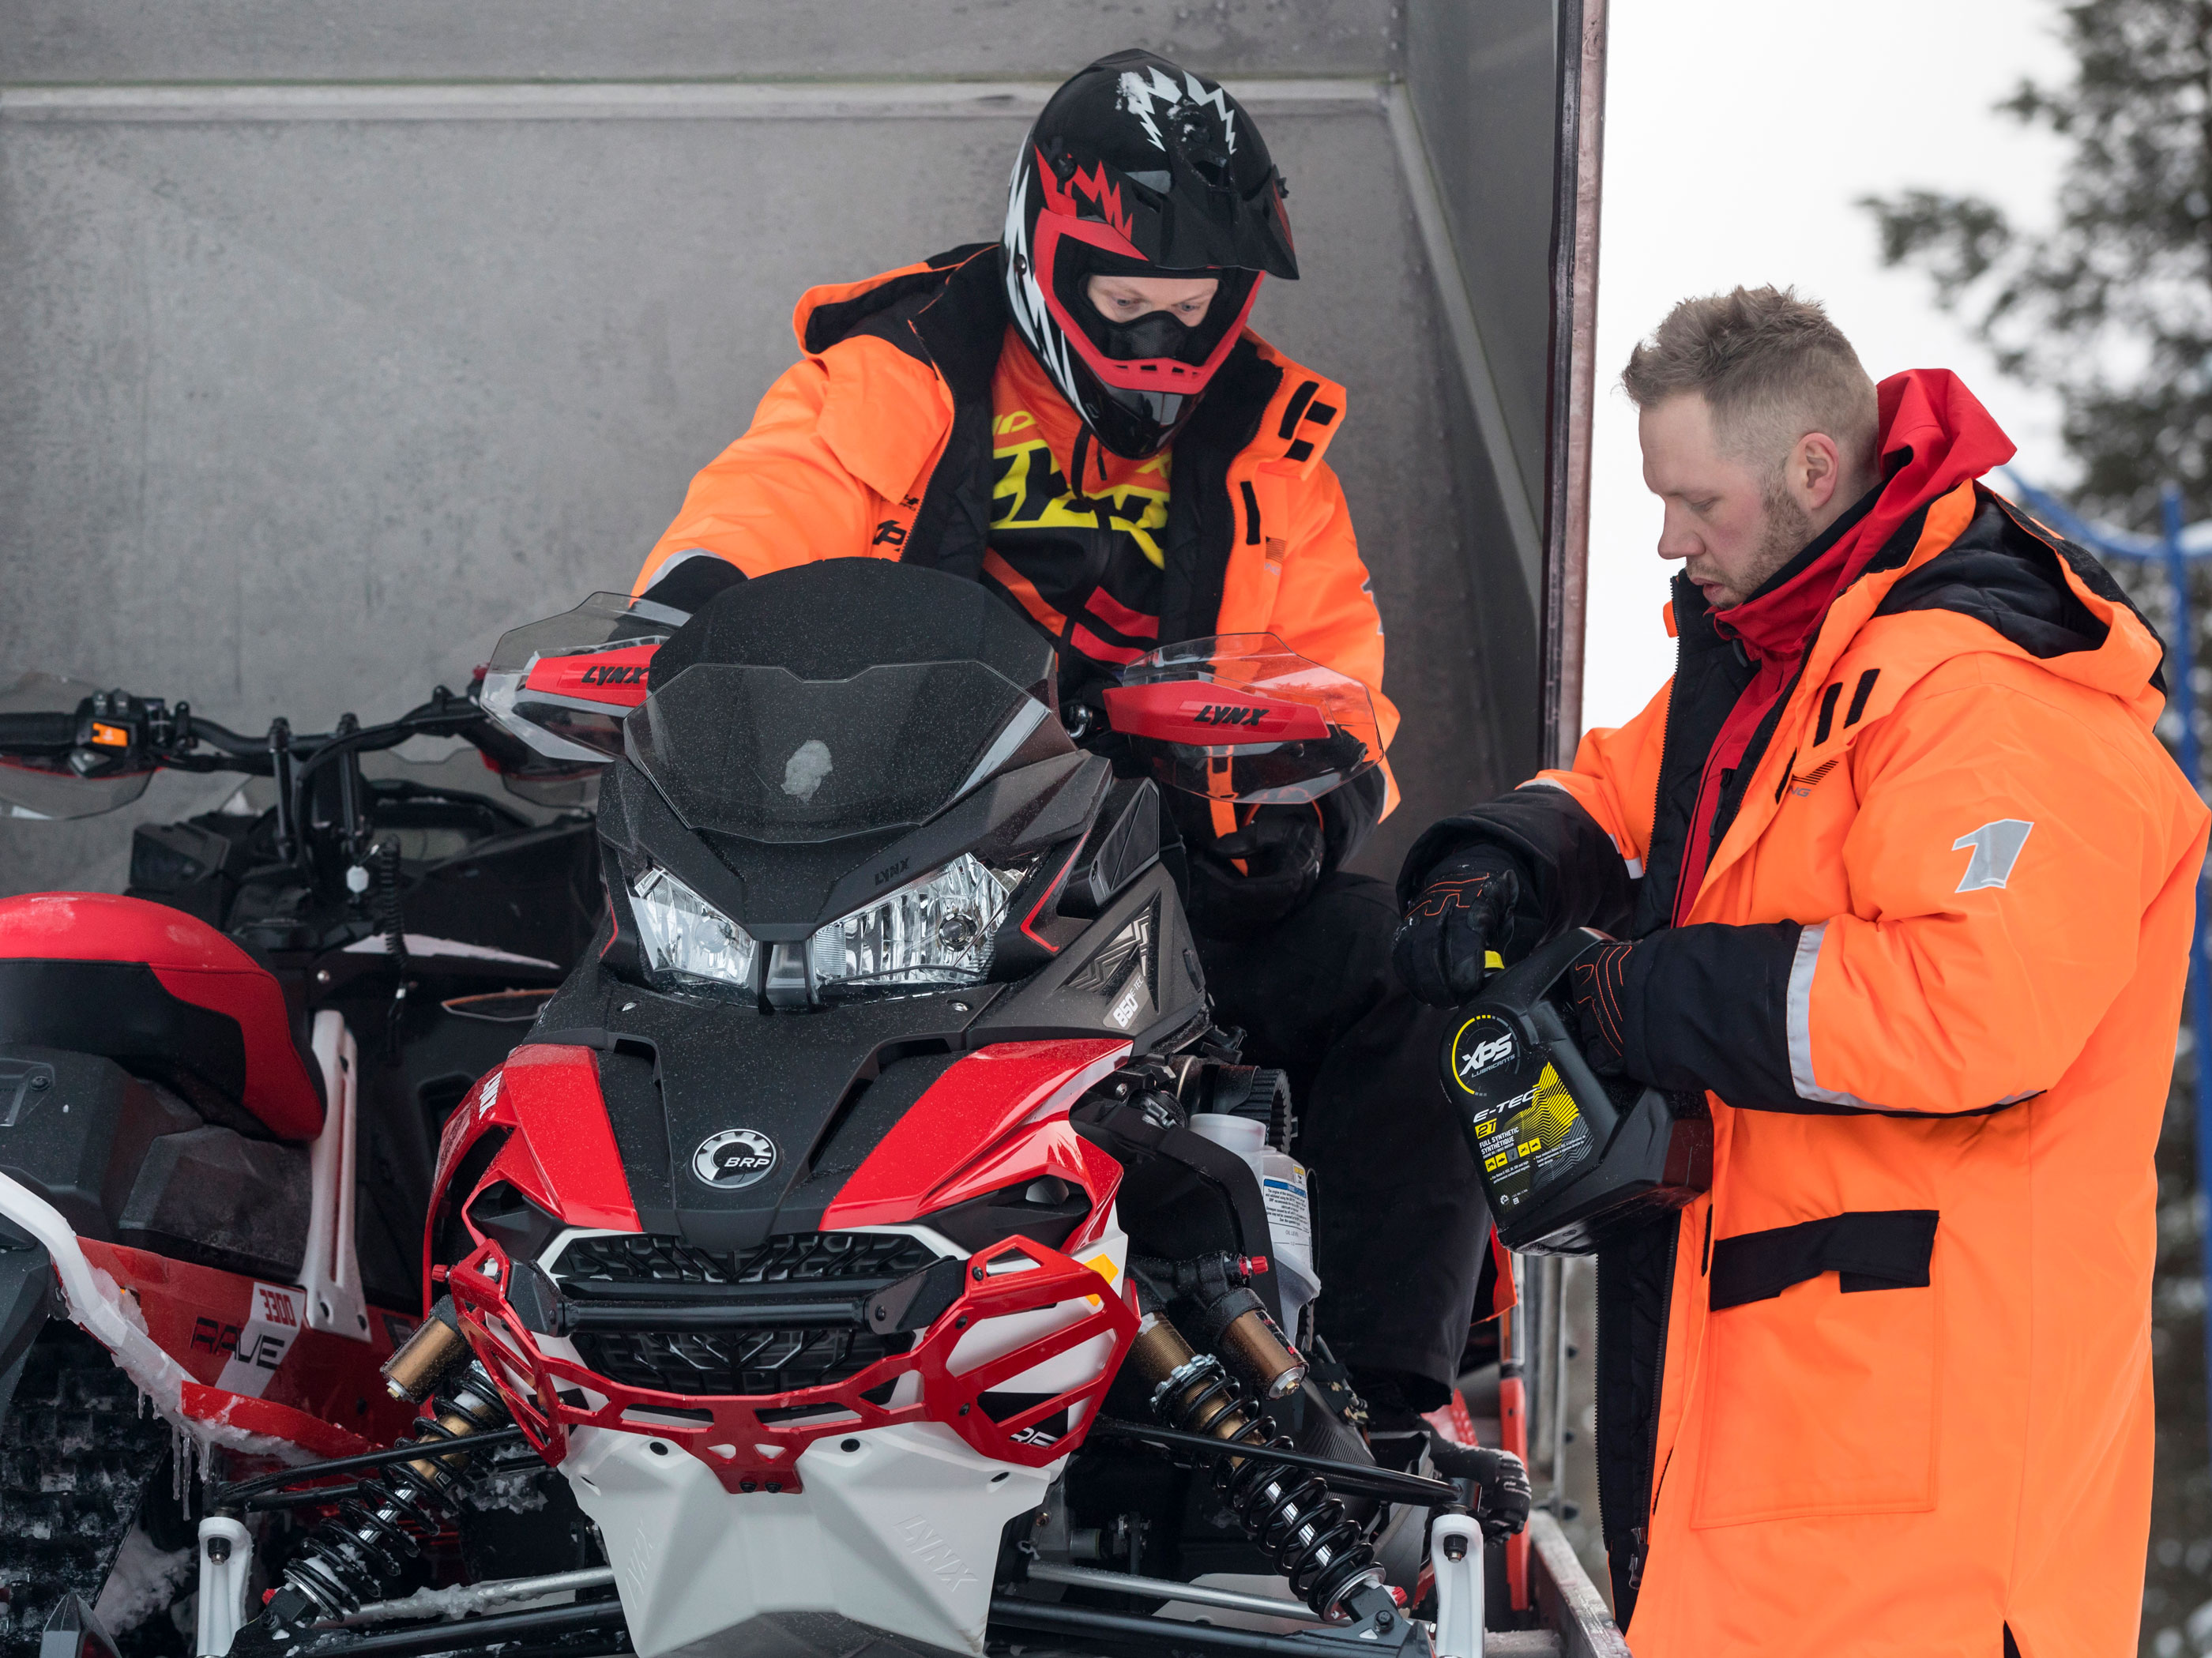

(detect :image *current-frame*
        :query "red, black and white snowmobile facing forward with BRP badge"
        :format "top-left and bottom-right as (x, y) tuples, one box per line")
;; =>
(181, 559), (1529, 1658)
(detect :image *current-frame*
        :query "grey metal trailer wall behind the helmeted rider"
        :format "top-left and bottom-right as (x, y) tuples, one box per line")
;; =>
(0, 0), (1553, 891)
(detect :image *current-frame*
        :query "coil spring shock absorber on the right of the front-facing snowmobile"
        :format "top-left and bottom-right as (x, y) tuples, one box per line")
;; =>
(1130, 1313), (1382, 1619)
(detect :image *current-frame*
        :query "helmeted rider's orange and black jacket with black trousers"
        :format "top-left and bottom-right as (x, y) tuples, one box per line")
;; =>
(635, 243), (1513, 1408)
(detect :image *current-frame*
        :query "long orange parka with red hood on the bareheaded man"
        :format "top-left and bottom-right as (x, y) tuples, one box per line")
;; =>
(1409, 376), (2207, 1658)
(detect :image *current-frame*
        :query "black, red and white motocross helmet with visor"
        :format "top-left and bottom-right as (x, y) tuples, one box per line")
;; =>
(1004, 51), (1299, 457)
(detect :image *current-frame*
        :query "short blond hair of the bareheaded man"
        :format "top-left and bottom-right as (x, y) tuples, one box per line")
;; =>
(1621, 288), (1880, 478)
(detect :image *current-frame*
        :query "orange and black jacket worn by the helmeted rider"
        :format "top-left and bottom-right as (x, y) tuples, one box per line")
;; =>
(633, 243), (1398, 831)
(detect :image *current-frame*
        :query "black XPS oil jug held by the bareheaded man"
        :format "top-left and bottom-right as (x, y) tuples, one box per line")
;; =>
(1443, 928), (1712, 1256)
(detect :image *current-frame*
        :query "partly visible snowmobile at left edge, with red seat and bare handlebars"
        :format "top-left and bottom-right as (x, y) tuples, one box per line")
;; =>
(0, 654), (604, 1656)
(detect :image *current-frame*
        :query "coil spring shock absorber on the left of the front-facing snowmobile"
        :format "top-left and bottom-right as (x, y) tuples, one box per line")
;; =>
(261, 1298), (511, 1631)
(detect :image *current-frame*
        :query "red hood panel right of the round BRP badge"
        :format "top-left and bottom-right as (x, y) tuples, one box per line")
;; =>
(823, 1037), (1128, 1231)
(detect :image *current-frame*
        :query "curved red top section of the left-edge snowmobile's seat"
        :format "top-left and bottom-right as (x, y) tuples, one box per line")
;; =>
(0, 893), (323, 1141)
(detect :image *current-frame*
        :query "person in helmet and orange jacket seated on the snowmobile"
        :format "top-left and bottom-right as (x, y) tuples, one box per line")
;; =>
(635, 51), (1487, 1432)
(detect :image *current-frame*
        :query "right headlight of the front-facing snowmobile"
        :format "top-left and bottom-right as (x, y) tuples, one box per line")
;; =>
(807, 853), (1031, 997)
